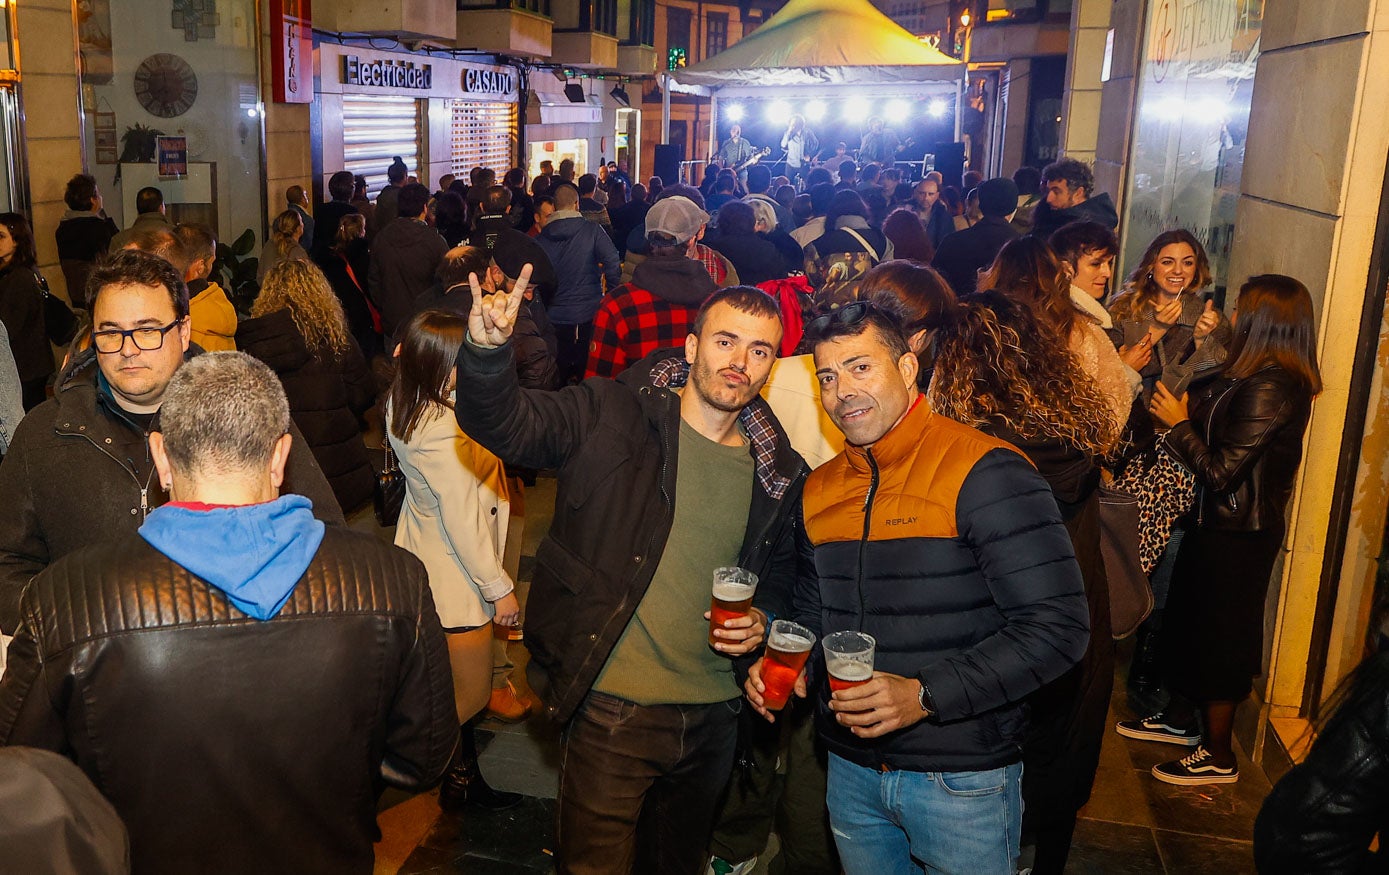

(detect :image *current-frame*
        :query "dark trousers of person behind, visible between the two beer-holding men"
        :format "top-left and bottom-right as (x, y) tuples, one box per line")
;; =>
(710, 696), (839, 875)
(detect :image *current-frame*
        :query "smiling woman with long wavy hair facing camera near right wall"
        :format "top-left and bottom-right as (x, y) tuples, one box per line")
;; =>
(1108, 228), (1232, 394)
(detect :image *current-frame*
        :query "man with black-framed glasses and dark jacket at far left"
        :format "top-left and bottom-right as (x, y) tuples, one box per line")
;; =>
(0, 250), (343, 632)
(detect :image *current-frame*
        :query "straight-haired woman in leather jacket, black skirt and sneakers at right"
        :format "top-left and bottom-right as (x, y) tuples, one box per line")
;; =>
(1118, 274), (1321, 785)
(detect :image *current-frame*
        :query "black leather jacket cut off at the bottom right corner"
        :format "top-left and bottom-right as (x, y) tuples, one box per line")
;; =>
(1254, 653), (1389, 875)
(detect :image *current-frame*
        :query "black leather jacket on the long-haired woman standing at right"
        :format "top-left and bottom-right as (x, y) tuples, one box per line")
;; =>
(1165, 365), (1311, 532)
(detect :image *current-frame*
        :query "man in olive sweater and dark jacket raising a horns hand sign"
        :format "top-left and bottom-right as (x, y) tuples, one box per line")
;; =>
(456, 276), (804, 875)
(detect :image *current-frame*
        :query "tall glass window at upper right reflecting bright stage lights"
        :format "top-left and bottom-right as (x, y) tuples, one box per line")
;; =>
(1121, 0), (1264, 297)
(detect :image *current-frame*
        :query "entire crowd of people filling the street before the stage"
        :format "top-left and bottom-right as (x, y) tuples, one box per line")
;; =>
(0, 149), (1368, 875)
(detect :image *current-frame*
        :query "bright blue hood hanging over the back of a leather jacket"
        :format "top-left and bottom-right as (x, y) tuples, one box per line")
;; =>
(140, 494), (324, 619)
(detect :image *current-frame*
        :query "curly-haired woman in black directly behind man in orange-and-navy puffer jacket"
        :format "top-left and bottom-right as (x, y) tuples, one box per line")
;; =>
(926, 292), (1120, 875)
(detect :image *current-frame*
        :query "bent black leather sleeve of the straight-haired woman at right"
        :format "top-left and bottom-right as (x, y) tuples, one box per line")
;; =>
(1165, 376), (1297, 493)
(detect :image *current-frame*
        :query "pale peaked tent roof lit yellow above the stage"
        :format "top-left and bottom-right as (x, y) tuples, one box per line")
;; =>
(667, 0), (960, 90)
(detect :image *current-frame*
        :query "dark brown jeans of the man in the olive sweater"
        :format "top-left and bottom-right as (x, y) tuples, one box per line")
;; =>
(556, 693), (742, 875)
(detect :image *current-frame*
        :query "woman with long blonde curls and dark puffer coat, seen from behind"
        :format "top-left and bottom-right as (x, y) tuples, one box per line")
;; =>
(236, 260), (376, 514)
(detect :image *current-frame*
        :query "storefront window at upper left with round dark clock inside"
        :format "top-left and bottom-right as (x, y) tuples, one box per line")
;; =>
(79, 0), (265, 240)
